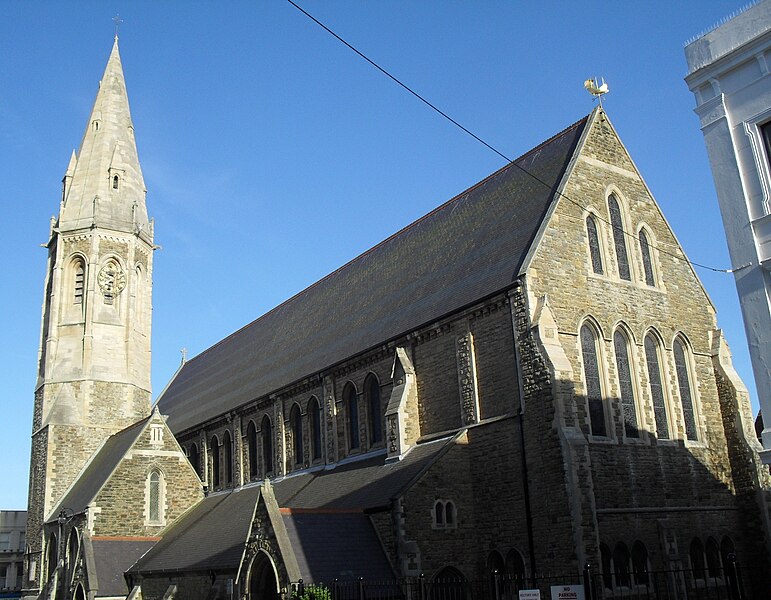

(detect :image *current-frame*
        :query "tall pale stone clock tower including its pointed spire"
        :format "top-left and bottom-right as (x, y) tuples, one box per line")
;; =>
(24, 36), (153, 592)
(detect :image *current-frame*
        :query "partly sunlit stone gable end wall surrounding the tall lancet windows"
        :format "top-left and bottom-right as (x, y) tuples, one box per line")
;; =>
(528, 113), (764, 566)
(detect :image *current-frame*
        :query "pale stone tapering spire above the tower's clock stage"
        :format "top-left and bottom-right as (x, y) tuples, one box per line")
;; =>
(58, 36), (151, 237)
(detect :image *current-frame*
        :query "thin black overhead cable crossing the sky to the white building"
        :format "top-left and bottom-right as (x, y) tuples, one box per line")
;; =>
(287, 0), (750, 273)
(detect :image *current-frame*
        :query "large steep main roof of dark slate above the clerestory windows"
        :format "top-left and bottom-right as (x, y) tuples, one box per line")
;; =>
(159, 117), (588, 433)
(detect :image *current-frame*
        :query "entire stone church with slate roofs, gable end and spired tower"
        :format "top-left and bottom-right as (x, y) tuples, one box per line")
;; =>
(24, 38), (771, 600)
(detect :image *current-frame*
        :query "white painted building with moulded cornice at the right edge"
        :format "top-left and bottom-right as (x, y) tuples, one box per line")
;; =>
(685, 0), (771, 464)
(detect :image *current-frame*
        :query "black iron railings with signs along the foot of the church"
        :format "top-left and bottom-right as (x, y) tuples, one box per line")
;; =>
(291, 562), (771, 600)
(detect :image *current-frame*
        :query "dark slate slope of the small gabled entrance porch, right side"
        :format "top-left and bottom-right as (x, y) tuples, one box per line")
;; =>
(282, 513), (394, 582)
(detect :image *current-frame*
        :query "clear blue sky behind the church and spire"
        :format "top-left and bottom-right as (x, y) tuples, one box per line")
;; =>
(0, 0), (757, 509)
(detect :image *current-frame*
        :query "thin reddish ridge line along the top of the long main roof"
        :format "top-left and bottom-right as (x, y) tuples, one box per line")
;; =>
(181, 111), (594, 366)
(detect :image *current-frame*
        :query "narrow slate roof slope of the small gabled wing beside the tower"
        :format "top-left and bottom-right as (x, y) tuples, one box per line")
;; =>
(48, 417), (150, 522)
